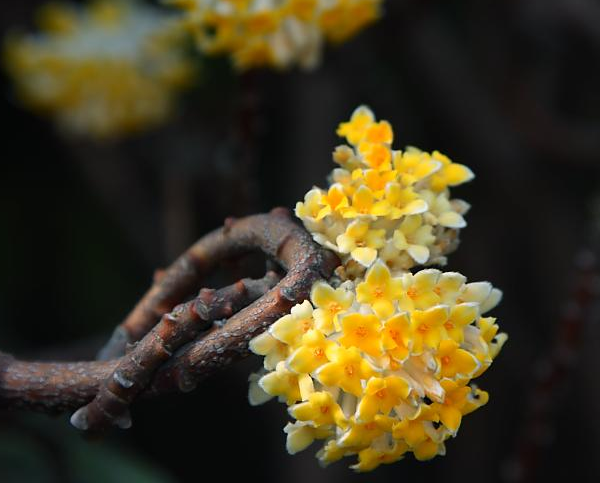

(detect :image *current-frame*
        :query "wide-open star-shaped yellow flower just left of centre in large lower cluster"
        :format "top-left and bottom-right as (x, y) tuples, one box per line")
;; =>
(315, 346), (374, 396)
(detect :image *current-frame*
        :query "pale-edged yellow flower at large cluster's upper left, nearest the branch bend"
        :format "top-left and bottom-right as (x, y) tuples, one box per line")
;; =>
(310, 282), (354, 335)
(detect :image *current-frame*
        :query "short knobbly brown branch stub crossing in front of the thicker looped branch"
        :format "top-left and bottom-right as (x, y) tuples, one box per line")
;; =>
(71, 272), (280, 430)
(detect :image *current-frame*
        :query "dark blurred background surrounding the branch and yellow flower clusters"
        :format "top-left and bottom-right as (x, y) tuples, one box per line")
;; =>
(0, 0), (600, 483)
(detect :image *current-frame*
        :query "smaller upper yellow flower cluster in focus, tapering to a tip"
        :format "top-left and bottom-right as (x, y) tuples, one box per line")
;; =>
(296, 106), (473, 276)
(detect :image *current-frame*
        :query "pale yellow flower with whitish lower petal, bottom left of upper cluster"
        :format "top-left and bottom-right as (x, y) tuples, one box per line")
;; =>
(336, 219), (385, 267)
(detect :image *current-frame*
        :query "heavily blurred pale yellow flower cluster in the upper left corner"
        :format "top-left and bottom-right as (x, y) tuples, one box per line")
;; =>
(5, 0), (193, 138)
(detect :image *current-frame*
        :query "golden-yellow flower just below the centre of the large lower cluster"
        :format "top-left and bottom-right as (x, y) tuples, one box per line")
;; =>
(356, 376), (410, 422)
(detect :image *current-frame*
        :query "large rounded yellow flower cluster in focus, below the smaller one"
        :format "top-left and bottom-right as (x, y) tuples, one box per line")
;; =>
(250, 261), (506, 471)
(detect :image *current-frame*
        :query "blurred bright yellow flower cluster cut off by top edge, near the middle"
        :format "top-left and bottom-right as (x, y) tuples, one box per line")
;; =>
(169, 0), (382, 69)
